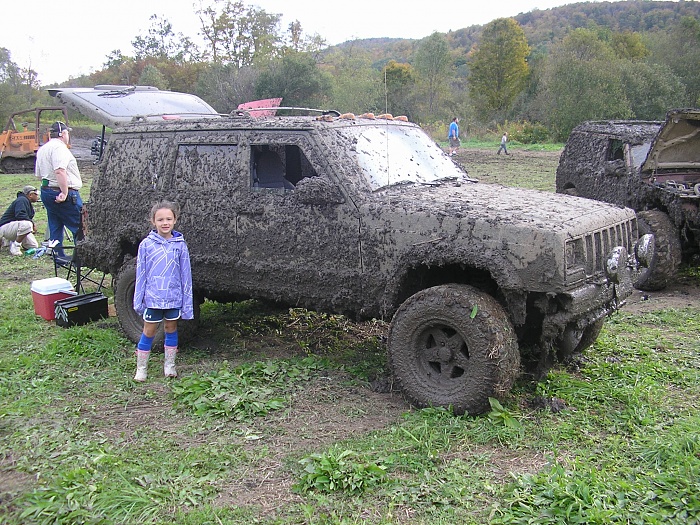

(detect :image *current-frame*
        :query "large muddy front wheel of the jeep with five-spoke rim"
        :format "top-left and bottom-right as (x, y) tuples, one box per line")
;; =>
(388, 284), (520, 415)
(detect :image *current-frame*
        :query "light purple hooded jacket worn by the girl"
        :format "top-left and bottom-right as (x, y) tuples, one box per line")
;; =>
(134, 231), (194, 319)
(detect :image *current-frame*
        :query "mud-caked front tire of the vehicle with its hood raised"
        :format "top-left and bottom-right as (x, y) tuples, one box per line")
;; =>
(634, 210), (681, 291)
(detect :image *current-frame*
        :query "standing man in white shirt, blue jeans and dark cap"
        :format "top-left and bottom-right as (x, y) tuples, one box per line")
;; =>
(34, 122), (83, 256)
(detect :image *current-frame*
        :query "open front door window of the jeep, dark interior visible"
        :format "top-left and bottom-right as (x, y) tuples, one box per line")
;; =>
(250, 144), (317, 191)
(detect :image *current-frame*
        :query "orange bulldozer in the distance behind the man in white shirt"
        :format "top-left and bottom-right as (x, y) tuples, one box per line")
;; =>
(0, 106), (68, 173)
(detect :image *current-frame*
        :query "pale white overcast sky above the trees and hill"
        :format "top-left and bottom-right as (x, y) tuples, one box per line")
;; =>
(0, 0), (672, 84)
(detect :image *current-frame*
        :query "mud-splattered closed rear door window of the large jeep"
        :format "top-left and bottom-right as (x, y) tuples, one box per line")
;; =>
(175, 144), (238, 190)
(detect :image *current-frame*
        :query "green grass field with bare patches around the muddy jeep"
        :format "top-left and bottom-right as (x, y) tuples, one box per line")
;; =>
(0, 148), (700, 525)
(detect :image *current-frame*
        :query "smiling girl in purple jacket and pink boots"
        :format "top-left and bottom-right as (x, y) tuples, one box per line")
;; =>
(134, 201), (194, 381)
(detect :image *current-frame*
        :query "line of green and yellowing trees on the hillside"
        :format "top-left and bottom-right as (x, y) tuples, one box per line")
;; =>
(0, 0), (700, 142)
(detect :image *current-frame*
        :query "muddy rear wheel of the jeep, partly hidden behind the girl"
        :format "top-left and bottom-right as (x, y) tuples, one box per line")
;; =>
(114, 259), (201, 350)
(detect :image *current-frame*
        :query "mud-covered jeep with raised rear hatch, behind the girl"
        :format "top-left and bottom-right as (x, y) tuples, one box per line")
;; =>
(57, 86), (653, 414)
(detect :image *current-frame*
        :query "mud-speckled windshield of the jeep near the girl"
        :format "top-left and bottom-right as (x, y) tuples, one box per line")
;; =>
(343, 123), (465, 191)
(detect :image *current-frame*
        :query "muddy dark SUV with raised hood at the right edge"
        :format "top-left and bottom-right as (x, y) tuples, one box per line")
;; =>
(556, 109), (700, 290)
